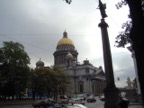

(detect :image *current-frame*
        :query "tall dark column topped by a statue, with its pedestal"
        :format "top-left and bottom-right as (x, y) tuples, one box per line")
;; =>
(98, 0), (119, 108)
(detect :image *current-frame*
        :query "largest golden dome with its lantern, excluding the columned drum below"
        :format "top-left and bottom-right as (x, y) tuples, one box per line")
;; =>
(57, 31), (74, 46)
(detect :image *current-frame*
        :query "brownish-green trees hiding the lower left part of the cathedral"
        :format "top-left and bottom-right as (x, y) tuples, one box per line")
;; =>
(31, 66), (69, 100)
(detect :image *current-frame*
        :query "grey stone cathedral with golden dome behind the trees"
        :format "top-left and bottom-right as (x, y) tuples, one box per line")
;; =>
(36, 31), (106, 95)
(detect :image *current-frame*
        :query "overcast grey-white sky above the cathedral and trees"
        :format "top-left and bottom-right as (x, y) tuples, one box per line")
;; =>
(0, 0), (135, 86)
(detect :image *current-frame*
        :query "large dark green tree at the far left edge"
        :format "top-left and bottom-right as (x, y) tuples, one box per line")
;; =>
(0, 41), (30, 99)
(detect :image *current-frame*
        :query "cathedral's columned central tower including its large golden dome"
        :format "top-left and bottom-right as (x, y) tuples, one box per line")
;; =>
(53, 31), (78, 68)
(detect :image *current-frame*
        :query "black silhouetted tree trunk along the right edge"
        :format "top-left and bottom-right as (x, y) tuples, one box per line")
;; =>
(126, 0), (144, 107)
